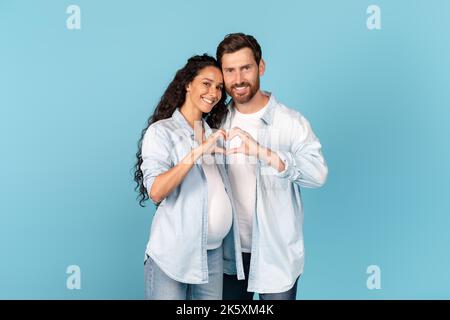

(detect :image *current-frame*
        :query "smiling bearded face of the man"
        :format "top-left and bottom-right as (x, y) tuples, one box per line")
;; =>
(222, 48), (264, 104)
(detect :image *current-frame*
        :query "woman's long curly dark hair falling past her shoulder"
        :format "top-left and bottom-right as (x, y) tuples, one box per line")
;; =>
(134, 54), (227, 207)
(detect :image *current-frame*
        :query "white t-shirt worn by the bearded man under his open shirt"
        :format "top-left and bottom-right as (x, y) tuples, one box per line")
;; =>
(228, 106), (267, 252)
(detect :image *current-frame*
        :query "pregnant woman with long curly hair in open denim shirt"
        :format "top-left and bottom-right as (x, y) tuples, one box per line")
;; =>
(135, 55), (243, 300)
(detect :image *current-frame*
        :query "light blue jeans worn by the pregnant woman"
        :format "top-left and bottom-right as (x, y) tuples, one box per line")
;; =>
(144, 247), (223, 300)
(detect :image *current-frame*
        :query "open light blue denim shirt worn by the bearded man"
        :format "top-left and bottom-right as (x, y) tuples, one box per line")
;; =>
(223, 92), (328, 293)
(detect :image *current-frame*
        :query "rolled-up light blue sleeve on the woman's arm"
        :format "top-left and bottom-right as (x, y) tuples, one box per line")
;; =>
(141, 126), (173, 201)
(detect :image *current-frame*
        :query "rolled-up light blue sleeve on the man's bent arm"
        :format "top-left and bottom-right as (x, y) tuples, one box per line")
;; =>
(277, 116), (328, 188)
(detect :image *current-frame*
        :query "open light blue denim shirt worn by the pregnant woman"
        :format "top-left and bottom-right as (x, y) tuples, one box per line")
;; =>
(141, 109), (244, 284)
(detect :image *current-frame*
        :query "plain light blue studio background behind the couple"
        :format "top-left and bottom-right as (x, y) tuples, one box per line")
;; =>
(0, 0), (450, 299)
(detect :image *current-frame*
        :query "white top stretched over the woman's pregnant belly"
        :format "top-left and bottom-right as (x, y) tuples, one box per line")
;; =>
(202, 156), (233, 250)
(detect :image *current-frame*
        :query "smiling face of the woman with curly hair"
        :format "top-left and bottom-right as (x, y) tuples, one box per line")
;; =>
(186, 66), (223, 113)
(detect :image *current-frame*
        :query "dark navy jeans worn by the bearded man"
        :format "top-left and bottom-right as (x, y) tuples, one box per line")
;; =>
(223, 252), (298, 300)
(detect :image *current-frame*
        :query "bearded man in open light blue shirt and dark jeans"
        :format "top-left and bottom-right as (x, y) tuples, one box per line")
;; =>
(217, 33), (328, 300)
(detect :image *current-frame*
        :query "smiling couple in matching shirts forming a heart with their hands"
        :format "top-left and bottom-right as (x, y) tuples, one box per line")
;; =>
(135, 33), (328, 300)
